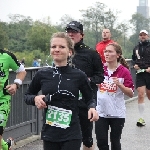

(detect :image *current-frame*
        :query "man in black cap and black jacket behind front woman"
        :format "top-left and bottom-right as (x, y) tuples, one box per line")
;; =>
(66, 21), (104, 150)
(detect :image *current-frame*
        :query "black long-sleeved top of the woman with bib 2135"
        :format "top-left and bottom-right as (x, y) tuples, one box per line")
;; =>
(24, 66), (96, 142)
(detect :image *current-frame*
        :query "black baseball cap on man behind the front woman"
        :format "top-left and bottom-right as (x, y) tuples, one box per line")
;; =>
(65, 21), (83, 32)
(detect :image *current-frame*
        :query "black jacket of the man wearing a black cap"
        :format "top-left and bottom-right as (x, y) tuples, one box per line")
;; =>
(72, 40), (104, 107)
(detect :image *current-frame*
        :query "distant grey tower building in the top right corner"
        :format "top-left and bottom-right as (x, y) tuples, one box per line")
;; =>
(137, 0), (149, 18)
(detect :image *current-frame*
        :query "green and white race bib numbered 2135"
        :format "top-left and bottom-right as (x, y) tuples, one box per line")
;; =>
(46, 105), (72, 129)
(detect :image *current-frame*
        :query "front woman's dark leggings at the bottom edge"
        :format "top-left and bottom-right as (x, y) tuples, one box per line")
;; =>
(43, 139), (81, 150)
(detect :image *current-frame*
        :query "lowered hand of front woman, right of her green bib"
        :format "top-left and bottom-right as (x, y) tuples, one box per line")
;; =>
(88, 108), (99, 122)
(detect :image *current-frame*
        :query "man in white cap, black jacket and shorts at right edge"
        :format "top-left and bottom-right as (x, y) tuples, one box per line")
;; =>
(132, 30), (150, 127)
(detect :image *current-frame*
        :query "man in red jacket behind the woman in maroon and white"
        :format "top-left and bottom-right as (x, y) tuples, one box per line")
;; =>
(96, 29), (114, 63)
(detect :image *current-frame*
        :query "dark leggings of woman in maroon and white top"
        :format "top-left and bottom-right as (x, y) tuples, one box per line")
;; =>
(95, 117), (125, 150)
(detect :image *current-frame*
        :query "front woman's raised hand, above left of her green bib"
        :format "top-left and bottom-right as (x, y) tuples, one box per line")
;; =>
(34, 95), (47, 109)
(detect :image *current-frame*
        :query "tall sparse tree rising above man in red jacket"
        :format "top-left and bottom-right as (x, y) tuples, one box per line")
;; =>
(80, 2), (122, 45)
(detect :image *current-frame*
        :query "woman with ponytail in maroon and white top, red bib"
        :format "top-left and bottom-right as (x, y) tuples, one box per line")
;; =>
(95, 43), (134, 150)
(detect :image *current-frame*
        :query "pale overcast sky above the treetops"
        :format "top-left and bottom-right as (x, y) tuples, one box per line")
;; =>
(0, 0), (150, 24)
